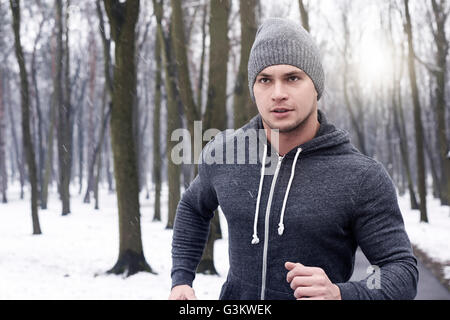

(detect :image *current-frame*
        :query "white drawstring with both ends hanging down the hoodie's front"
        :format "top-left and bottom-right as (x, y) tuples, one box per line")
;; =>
(252, 144), (302, 244)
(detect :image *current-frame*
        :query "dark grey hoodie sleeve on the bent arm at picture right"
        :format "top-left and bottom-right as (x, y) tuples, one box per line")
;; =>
(337, 162), (418, 300)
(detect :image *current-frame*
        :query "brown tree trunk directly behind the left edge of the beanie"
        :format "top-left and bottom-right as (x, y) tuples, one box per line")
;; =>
(233, 0), (258, 129)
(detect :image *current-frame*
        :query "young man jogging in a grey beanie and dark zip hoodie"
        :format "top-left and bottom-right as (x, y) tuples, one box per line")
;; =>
(169, 19), (418, 300)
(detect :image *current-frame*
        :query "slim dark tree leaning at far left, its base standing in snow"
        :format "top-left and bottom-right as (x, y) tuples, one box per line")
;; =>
(10, 0), (42, 235)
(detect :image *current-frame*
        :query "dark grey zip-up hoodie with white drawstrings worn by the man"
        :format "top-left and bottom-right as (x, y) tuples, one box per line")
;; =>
(171, 110), (418, 300)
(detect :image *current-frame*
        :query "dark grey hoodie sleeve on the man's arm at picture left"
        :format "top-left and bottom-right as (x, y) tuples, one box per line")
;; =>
(171, 143), (218, 288)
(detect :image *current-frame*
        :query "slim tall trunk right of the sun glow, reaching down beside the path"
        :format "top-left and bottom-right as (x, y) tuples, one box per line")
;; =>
(404, 0), (428, 222)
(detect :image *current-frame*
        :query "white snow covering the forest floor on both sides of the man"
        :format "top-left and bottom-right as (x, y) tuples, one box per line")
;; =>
(0, 185), (450, 300)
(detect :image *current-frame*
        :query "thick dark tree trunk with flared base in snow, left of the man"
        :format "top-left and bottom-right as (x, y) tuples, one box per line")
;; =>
(103, 0), (152, 276)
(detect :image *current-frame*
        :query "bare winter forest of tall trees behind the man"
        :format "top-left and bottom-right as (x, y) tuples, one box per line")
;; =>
(0, 0), (450, 276)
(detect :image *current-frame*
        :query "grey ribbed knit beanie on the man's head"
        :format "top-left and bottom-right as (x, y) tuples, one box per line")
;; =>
(248, 18), (325, 101)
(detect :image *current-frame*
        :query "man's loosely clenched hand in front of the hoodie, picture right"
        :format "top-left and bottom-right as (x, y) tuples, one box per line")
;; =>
(284, 262), (341, 300)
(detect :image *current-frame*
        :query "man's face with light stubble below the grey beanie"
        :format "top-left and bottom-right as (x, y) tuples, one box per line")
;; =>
(253, 65), (317, 133)
